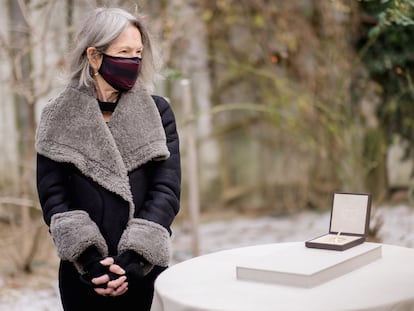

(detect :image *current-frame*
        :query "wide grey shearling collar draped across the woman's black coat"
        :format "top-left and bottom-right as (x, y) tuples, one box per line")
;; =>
(35, 81), (169, 216)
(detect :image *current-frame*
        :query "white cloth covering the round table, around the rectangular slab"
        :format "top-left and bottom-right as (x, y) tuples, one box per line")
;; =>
(151, 242), (414, 311)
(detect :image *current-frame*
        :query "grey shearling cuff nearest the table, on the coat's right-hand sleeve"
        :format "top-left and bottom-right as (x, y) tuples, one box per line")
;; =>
(118, 218), (171, 267)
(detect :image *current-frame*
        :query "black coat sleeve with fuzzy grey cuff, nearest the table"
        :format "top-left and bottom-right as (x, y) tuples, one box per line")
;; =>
(118, 96), (181, 266)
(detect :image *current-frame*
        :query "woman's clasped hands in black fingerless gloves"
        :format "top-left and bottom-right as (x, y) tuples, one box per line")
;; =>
(81, 251), (145, 297)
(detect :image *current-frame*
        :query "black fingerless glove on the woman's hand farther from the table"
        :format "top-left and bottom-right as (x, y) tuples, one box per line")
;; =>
(78, 246), (120, 288)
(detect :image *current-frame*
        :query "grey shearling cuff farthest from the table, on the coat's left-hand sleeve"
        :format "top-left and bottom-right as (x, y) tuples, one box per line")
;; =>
(50, 210), (108, 262)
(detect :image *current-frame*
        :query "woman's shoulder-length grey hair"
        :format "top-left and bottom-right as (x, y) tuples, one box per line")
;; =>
(69, 8), (161, 91)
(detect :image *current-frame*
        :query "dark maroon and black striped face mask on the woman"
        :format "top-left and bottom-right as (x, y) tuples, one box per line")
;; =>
(98, 53), (142, 92)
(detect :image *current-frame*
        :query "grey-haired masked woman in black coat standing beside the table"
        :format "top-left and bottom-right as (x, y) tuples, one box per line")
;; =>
(36, 8), (181, 311)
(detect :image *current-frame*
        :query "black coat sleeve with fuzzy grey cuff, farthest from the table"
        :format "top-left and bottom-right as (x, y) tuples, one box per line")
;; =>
(36, 154), (108, 263)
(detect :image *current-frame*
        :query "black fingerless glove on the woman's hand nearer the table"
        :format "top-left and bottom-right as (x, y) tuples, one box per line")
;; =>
(114, 250), (148, 284)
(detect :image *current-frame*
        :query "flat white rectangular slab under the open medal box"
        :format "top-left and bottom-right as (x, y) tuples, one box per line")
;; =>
(236, 242), (381, 288)
